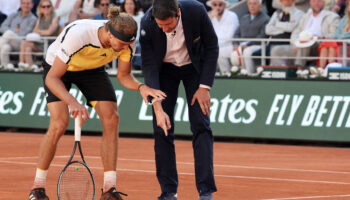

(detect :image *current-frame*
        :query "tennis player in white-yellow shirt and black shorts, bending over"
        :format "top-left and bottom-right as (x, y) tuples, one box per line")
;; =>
(29, 6), (166, 200)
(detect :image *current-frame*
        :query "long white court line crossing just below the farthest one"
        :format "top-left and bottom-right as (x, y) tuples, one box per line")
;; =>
(0, 160), (350, 185)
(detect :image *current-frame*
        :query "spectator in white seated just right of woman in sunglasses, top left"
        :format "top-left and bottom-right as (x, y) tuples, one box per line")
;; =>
(51, 0), (77, 27)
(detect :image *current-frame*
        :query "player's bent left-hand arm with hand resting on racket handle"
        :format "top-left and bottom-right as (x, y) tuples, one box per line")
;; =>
(45, 56), (89, 123)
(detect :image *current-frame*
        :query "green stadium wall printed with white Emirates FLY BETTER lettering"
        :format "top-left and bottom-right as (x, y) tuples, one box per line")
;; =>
(0, 72), (350, 142)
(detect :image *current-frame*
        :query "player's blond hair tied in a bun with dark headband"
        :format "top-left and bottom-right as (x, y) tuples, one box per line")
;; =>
(105, 5), (137, 38)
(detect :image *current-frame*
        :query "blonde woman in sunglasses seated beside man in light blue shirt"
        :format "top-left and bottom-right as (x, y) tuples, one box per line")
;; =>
(18, 0), (58, 70)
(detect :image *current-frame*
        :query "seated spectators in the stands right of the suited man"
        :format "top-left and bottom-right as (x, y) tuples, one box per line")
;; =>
(207, 0), (350, 76)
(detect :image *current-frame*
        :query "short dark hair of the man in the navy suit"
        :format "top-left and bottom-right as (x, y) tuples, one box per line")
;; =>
(152, 0), (179, 20)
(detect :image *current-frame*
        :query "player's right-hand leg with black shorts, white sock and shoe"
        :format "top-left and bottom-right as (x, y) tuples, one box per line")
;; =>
(74, 68), (120, 199)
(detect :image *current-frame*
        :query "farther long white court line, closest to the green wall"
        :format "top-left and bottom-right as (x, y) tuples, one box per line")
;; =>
(0, 155), (350, 174)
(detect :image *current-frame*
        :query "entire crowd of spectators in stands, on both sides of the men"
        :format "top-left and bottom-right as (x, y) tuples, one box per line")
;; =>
(0, 0), (350, 76)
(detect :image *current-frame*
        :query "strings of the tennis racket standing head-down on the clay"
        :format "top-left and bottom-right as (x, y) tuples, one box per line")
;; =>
(59, 163), (94, 200)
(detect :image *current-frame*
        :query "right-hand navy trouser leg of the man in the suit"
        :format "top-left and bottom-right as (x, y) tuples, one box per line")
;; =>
(183, 67), (216, 199)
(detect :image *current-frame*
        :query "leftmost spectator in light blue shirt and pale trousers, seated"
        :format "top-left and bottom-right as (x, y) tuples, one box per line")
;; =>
(0, 0), (36, 69)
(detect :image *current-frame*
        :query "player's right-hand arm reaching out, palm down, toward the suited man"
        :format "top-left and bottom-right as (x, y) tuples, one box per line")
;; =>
(117, 59), (166, 103)
